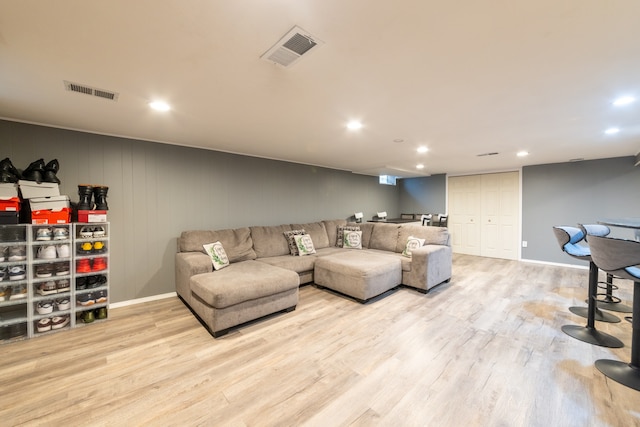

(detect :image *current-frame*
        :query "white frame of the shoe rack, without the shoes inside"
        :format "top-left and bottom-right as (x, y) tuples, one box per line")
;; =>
(0, 222), (111, 344)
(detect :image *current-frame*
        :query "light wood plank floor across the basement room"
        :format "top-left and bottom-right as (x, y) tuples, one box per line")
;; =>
(0, 255), (640, 427)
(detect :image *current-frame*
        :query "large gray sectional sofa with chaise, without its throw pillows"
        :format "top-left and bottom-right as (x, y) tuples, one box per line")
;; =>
(175, 220), (452, 337)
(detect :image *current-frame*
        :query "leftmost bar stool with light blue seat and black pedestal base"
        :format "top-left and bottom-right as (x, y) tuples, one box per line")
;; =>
(553, 226), (624, 348)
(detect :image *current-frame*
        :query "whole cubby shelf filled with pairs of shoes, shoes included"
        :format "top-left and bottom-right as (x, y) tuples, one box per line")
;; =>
(0, 223), (109, 343)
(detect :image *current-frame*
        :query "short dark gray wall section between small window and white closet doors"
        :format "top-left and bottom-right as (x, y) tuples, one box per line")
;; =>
(398, 174), (447, 217)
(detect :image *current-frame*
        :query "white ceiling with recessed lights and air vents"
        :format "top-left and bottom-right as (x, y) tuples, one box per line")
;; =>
(0, 0), (640, 177)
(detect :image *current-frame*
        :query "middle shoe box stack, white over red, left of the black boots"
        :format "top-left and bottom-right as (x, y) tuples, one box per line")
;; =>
(18, 180), (71, 224)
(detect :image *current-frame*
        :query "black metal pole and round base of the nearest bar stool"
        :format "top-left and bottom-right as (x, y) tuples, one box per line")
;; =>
(596, 282), (640, 391)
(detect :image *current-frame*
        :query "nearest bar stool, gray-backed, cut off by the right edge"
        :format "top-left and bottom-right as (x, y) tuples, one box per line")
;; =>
(589, 236), (640, 391)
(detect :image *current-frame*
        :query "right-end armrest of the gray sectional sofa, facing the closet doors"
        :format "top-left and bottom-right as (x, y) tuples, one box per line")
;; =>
(402, 245), (453, 292)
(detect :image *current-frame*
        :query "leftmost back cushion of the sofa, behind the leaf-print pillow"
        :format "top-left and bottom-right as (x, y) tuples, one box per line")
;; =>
(179, 227), (256, 262)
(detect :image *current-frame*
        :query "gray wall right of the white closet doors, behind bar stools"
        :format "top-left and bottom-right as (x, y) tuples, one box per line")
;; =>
(522, 157), (640, 265)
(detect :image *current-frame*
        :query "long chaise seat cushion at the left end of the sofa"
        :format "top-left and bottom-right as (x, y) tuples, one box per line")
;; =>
(190, 261), (300, 308)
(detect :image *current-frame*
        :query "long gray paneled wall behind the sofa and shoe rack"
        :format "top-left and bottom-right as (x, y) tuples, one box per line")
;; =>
(0, 120), (398, 302)
